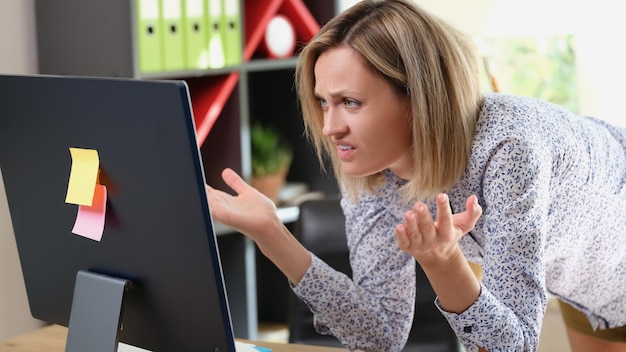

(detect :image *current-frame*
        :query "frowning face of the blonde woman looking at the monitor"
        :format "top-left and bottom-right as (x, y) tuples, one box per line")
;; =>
(314, 47), (413, 179)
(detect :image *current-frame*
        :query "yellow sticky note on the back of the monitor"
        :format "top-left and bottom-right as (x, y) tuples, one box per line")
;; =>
(65, 148), (100, 206)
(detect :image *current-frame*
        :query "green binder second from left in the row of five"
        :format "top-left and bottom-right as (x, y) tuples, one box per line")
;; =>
(161, 0), (185, 71)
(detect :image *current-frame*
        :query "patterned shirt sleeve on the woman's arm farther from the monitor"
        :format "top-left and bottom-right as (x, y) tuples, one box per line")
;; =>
(436, 138), (551, 352)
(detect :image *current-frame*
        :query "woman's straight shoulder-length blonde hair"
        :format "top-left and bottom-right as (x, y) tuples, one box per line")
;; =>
(296, 0), (482, 199)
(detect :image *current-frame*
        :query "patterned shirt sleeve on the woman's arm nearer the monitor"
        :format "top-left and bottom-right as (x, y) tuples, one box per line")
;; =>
(293, 184), (415, 351)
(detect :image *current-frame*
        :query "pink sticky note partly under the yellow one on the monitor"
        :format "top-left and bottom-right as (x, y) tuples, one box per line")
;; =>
(72, 184), (107, 241)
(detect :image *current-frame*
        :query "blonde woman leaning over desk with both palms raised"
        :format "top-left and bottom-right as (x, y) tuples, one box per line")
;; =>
(208, 0), (626, 351)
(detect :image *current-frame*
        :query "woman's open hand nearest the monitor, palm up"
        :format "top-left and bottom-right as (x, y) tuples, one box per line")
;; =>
(206, 168), (280, 242)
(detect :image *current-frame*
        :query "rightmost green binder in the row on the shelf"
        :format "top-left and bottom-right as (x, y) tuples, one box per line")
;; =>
(222, 0), (243, 66)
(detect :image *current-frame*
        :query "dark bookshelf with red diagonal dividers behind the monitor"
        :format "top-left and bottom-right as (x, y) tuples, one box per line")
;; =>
(35, 0), (337, 339)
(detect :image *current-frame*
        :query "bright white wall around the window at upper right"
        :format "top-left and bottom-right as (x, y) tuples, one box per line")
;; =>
(415, 0), (626, 126)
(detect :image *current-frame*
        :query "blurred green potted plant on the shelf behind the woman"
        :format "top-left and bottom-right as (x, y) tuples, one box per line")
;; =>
(250, 122), (293, 204)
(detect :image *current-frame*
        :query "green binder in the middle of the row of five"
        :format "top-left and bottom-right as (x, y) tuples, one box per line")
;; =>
(183, 0), (209, 70)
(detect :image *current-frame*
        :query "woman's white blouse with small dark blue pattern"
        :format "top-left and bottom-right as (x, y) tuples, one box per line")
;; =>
(294, 94), (626, 352)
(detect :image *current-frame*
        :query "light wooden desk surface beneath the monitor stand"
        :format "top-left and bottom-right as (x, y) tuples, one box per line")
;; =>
(0, 325), (346, 352)
